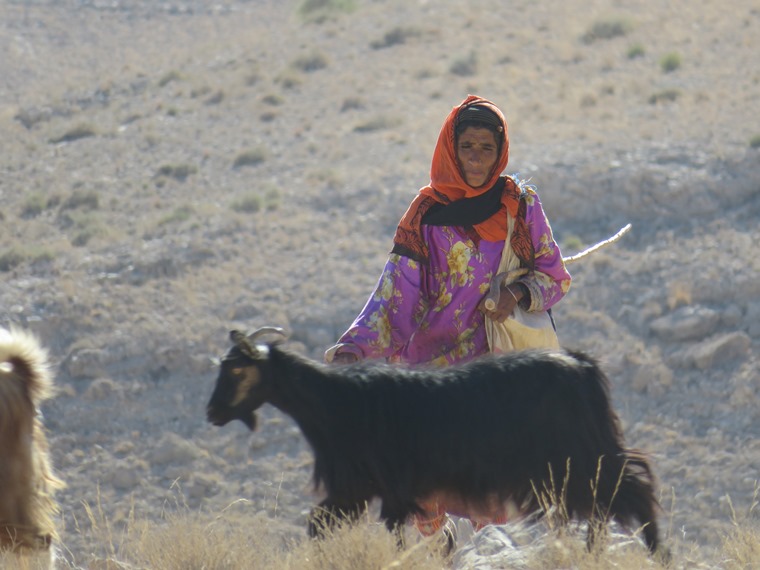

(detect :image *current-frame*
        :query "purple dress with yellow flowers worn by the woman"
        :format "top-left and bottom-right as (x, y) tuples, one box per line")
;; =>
(327, 185), (571, 366)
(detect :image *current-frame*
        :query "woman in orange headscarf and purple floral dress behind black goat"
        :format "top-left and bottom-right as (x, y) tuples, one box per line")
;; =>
(325, 95), (571, 366)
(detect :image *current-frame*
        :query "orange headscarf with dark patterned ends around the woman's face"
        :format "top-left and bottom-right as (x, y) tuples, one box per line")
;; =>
(393, 95), (524, 260)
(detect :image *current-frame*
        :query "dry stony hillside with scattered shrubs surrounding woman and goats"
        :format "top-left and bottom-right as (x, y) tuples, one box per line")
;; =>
(0, 0), (760, 570)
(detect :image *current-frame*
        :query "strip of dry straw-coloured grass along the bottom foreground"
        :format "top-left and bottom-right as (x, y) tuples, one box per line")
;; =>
(28, 500), (760, 570)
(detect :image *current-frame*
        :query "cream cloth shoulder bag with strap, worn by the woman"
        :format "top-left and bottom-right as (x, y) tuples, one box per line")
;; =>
(486, 214), (559, 353)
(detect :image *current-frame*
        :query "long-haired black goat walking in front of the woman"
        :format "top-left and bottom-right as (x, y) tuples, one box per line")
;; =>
(207, 327), (659, 552)
